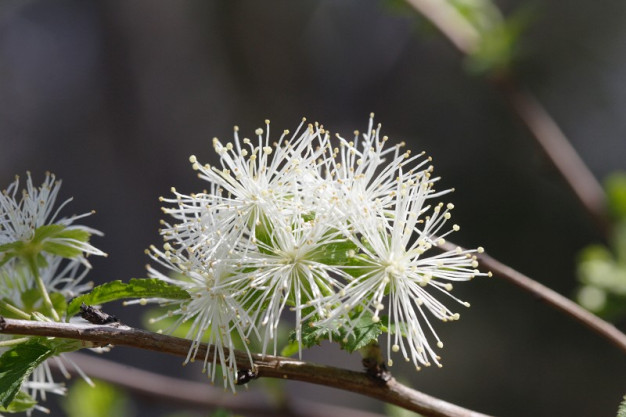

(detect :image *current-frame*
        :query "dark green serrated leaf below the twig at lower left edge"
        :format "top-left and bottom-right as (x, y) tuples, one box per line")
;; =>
(0, 338), (55, 407)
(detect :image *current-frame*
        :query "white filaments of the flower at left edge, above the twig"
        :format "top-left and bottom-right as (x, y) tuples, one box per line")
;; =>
(0, 173), (106, 266)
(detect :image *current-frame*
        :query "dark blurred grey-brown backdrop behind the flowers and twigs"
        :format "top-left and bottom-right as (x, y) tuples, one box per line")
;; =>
(0, 0), (626, 417)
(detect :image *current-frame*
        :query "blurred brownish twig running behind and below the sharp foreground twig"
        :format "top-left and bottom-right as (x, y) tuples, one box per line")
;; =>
(50, 352), (382, 417)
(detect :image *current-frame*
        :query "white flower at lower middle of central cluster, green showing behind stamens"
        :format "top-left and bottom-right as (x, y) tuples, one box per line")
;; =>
(224, 213), (349, 355)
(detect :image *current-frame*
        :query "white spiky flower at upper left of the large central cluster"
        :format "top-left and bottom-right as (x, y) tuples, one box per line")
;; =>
(161, 119), (328, 256)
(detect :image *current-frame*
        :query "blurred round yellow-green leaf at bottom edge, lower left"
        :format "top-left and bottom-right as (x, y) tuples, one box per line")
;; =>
(62, 380), (131, 417)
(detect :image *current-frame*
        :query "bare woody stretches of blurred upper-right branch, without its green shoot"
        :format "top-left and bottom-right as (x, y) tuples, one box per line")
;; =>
(406, 0), (610, 237)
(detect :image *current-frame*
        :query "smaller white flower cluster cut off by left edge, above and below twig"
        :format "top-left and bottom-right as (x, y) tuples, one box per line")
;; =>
(0, 173), (105, 411)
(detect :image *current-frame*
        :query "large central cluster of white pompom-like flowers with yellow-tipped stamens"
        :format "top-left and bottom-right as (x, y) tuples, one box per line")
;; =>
(149, 115), (484, 389)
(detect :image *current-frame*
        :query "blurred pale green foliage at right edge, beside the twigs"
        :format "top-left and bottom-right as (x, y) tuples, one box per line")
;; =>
(577, 172), (626, 320)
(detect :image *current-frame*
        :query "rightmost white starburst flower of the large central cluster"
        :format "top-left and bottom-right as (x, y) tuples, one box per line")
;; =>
(319, 172), (485, 369)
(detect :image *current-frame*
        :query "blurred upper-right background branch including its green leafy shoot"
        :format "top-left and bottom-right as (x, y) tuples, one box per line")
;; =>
(406, 0), (610, 238)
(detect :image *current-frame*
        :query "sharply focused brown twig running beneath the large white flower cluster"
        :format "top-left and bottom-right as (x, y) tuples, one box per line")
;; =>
(0, 317), (486, 417)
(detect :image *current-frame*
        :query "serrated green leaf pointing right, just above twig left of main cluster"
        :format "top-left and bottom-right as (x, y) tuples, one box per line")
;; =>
(67, 278), (190, 320)
